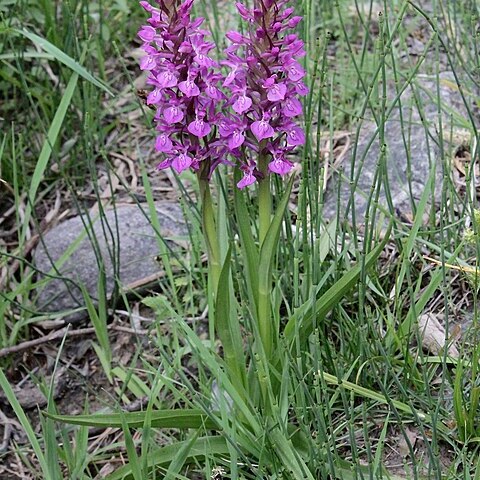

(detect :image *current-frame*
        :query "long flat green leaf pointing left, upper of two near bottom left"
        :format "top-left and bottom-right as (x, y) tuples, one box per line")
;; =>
(45, 409), (218, 430)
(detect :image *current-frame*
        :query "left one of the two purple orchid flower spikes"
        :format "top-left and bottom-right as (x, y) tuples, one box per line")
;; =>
(138, 0), (226, 175)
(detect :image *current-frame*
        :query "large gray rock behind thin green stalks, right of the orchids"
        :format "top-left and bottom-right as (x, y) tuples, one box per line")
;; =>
(323, 72), (476, 223)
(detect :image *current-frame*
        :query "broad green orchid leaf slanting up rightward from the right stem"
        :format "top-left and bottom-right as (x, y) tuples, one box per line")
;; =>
(284, 225), (391, 344)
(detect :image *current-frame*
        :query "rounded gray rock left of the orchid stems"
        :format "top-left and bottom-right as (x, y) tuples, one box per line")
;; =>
(33, 202), (188, 322)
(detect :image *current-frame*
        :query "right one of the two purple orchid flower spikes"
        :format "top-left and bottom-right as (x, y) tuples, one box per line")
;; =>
(219, 0), (308, 188)
